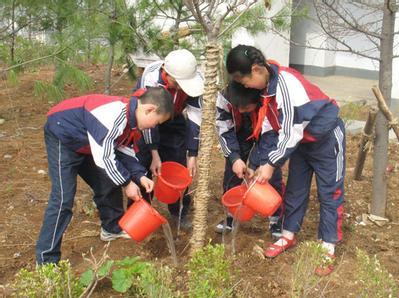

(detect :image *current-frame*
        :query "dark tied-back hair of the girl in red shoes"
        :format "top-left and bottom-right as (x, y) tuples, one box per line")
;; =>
(226, 44), (269, 75)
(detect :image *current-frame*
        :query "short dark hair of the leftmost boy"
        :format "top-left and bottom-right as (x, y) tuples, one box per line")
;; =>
(139, 87), (174, 118)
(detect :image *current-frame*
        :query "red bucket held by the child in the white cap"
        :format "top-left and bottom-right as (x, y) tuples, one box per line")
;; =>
(154, 161), (192, 204)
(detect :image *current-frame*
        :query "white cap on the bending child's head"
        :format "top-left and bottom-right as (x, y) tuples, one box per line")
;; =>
(164, 49), (204, 97)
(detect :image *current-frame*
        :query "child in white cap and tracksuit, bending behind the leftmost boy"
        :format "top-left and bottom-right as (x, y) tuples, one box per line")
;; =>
(137, 49), (204, 228)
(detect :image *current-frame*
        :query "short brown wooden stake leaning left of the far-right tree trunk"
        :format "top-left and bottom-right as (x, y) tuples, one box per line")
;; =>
(353, 109), (377, 180)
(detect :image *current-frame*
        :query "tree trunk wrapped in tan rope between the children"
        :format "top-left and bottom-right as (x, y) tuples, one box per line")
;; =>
(191, 41), (219, 254)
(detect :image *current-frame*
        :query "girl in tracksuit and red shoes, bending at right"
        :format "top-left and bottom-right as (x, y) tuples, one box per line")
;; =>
(226, 45), (345, 274)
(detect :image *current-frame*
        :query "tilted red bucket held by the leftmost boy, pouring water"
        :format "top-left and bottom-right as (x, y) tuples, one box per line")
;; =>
(119, 199), (167, 242)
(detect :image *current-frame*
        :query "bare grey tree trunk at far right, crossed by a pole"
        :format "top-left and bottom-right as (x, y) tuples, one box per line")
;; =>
(370, 0), (395, 217)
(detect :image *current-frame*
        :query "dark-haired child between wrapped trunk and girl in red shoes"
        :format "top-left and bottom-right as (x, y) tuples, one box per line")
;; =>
(215, 81), (283, 237)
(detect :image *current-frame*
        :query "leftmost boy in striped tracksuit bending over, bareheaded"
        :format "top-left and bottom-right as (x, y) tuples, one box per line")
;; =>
(36, 87), (173, 264)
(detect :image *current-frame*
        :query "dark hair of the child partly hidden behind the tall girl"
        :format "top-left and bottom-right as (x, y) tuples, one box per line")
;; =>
(225, 81), (262, 107)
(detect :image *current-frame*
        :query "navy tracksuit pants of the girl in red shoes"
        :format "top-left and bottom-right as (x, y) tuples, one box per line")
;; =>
(283, 119), (345, 243)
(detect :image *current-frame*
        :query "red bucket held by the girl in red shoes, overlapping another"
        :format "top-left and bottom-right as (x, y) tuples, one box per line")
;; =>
(243, 183), (283, 216)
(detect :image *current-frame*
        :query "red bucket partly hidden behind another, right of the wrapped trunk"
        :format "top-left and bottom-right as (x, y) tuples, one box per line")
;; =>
(222, 185), (255, 221)
